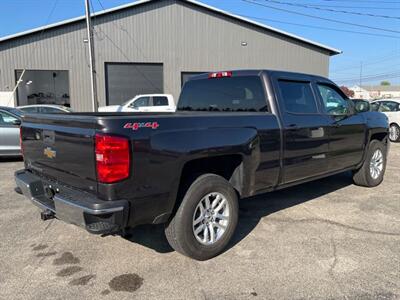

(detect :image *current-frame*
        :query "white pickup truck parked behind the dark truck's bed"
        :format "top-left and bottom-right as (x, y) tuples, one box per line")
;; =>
(99, 94), (176, 112)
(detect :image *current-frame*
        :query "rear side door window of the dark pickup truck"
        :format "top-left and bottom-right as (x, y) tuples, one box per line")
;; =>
(279, 80), (318, 114)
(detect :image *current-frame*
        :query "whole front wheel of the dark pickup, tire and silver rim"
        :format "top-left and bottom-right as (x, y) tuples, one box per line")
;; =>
(353, 140), (386, 187)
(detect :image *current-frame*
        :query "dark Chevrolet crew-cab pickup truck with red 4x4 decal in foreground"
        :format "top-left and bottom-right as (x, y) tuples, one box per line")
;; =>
(15, 70), (389, 260)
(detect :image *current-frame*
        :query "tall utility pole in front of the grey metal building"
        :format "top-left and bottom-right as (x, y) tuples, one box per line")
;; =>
(85, 0), (98, 112)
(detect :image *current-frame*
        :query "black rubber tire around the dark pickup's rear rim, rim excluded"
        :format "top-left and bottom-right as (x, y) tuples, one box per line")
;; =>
(165, 174), (239, 260)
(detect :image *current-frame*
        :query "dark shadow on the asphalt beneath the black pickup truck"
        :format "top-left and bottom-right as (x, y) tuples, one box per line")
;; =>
(126, 172), (353, 253)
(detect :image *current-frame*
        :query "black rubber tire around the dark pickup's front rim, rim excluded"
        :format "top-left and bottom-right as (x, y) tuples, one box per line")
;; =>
(353, 140), (387, 187)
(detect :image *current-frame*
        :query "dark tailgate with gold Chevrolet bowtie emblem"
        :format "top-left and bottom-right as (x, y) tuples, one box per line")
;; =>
(21, 114), (97, 192)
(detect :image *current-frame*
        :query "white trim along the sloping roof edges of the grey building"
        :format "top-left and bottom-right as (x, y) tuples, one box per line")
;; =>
(0, 0), (342, 54)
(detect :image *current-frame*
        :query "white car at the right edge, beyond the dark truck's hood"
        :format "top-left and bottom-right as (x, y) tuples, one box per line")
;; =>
(371, 99), (400, 142)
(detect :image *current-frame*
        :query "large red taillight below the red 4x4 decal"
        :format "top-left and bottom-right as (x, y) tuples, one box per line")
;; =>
(95, 134), (130, 183)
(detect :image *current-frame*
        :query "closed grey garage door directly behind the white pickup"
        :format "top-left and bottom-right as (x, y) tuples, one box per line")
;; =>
(106, 63), (164, 105)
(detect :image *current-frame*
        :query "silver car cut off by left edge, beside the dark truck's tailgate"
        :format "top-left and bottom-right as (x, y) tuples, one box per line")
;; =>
(0, 106), (22, 157)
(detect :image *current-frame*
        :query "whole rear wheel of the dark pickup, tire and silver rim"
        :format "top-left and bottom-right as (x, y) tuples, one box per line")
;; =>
(165, 174), (239, 260)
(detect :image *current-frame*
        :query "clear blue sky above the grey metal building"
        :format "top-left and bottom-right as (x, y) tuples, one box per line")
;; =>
(0, 0), (400, 85)
